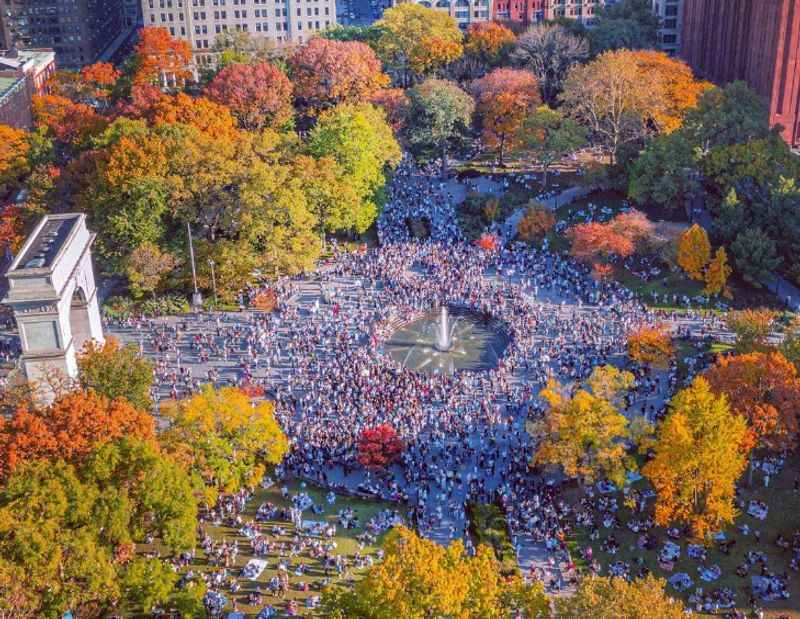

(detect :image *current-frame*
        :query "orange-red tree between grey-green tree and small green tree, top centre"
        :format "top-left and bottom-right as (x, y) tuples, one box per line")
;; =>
(472, 68), (541, 165)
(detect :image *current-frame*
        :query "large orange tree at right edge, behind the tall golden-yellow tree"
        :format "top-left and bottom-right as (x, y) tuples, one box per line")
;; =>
(704, 352), (800, 450)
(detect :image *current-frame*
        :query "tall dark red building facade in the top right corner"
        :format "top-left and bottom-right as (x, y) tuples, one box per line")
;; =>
(681, 0), (800, 147)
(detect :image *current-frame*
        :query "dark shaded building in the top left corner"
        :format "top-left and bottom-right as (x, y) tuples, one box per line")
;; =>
(0, 0), (123, 69)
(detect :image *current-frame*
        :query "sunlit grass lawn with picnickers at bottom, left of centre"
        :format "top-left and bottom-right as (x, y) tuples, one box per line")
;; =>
(139, 482), (405, 617)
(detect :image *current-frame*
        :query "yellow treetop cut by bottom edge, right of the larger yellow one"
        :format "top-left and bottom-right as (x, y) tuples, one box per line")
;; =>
(555, 575), (685, 619)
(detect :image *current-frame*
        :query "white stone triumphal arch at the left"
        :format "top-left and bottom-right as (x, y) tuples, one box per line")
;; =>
(2, 213), (104, 400)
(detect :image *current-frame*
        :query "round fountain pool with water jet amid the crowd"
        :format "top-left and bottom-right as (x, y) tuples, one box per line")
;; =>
(384, 307), (508, 374)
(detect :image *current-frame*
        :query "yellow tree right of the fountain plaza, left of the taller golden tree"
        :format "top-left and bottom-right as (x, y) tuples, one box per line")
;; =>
(534, 366), (634, 486)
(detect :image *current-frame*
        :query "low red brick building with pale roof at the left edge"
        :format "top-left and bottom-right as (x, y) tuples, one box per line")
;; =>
(0, 49), (56, 128)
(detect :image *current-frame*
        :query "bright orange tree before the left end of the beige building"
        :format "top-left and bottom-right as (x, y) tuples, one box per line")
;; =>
(133, 26), (192, 86)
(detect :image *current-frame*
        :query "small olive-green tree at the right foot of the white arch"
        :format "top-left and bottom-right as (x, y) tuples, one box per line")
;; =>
(78, 337), (153, 411)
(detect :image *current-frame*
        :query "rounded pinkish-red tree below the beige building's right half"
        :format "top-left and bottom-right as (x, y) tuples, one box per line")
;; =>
(206, 62), (293, 131)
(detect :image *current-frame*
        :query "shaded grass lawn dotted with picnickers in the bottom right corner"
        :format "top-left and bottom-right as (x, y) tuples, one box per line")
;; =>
(570, 453), (800, 619)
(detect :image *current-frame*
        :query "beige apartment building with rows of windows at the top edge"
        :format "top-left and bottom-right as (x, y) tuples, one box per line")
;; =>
(142, 0), (336, 55)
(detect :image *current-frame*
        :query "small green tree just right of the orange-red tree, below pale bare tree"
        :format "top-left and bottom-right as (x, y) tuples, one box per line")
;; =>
(520, 106), (587, 187)
